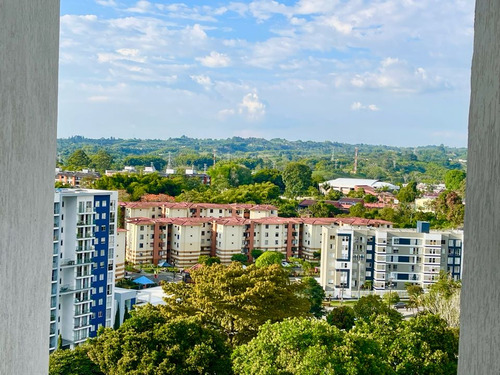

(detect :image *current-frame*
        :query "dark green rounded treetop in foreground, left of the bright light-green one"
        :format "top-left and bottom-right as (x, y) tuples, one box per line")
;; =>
(88, 305), (231, 375)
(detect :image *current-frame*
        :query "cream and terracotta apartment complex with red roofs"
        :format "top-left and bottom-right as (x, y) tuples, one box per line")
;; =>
(126, 202), (392, 268)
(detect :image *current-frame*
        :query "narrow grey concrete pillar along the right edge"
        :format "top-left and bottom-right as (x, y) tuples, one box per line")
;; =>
(459, 0), (500, 375)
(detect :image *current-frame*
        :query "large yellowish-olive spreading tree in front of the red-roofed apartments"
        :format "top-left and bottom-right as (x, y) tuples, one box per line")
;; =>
(162, 262), (310, 344)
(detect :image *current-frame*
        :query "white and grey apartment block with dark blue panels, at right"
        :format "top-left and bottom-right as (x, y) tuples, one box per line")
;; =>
(320, 223), (463, 297)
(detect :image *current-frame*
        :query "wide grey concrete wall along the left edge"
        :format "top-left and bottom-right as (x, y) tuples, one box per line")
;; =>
(0, 0), (59, 374)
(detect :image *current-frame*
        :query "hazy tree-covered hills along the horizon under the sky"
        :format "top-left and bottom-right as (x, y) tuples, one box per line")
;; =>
(57, 136), (467, 183)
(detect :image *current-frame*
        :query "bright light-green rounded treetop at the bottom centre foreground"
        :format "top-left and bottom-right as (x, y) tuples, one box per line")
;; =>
(232, 318), (392, 375)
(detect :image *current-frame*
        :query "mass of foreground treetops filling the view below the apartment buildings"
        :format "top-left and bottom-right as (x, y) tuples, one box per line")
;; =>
(49, 263), (459, 375)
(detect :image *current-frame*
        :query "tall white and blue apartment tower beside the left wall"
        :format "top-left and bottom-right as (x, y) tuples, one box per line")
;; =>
(49, 189), (118, 351)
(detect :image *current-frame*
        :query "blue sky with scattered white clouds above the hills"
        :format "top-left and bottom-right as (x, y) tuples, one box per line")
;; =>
(58, 0), (474, 147)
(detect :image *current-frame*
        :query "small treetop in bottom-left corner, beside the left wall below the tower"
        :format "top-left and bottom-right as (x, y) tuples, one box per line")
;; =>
(49, 345), (104, 375)
